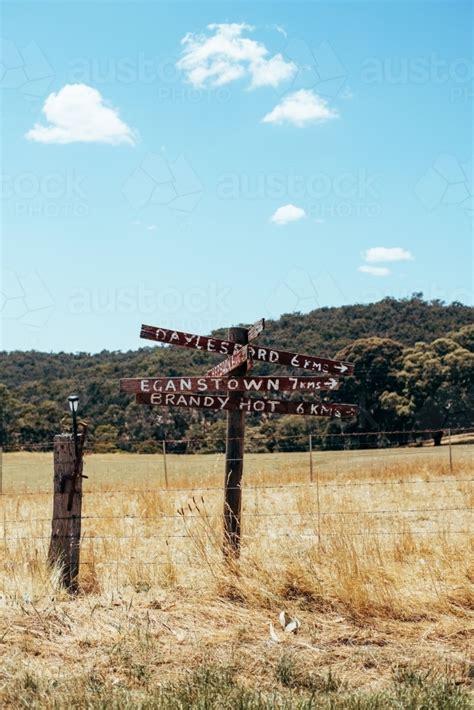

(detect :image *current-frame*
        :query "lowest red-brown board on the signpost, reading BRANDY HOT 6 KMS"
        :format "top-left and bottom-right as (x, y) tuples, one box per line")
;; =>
(135, 392), (358, 419)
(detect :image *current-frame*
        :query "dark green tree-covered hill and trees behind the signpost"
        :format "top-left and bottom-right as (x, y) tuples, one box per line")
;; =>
(0, 294), (474, 452)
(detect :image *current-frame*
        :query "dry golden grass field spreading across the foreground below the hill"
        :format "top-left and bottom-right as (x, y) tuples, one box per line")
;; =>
(0, 445), (474, 708)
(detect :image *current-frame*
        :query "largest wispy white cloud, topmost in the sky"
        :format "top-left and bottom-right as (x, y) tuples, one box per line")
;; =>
(176, 23), (297, 88)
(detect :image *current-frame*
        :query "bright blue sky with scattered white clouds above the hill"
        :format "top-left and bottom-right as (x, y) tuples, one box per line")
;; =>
(0, 2), (473, 352)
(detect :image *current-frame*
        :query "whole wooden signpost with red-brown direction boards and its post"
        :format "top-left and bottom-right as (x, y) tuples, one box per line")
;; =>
(120, 319), (358, 556)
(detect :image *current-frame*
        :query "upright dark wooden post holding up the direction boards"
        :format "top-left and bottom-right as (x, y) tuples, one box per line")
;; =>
(224, 328), (248, 557)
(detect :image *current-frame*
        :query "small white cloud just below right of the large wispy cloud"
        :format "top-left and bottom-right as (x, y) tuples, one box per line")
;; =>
(262, 89), (339, 126)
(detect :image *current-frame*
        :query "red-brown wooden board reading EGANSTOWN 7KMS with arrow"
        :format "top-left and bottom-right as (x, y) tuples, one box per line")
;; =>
(120, 376), (340, 394)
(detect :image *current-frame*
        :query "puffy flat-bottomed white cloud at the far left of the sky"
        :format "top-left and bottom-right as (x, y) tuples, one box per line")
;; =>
(26, 84), (136, 145)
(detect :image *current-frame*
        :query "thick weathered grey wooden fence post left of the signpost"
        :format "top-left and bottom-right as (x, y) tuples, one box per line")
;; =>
(48, 434), (84, 592)
